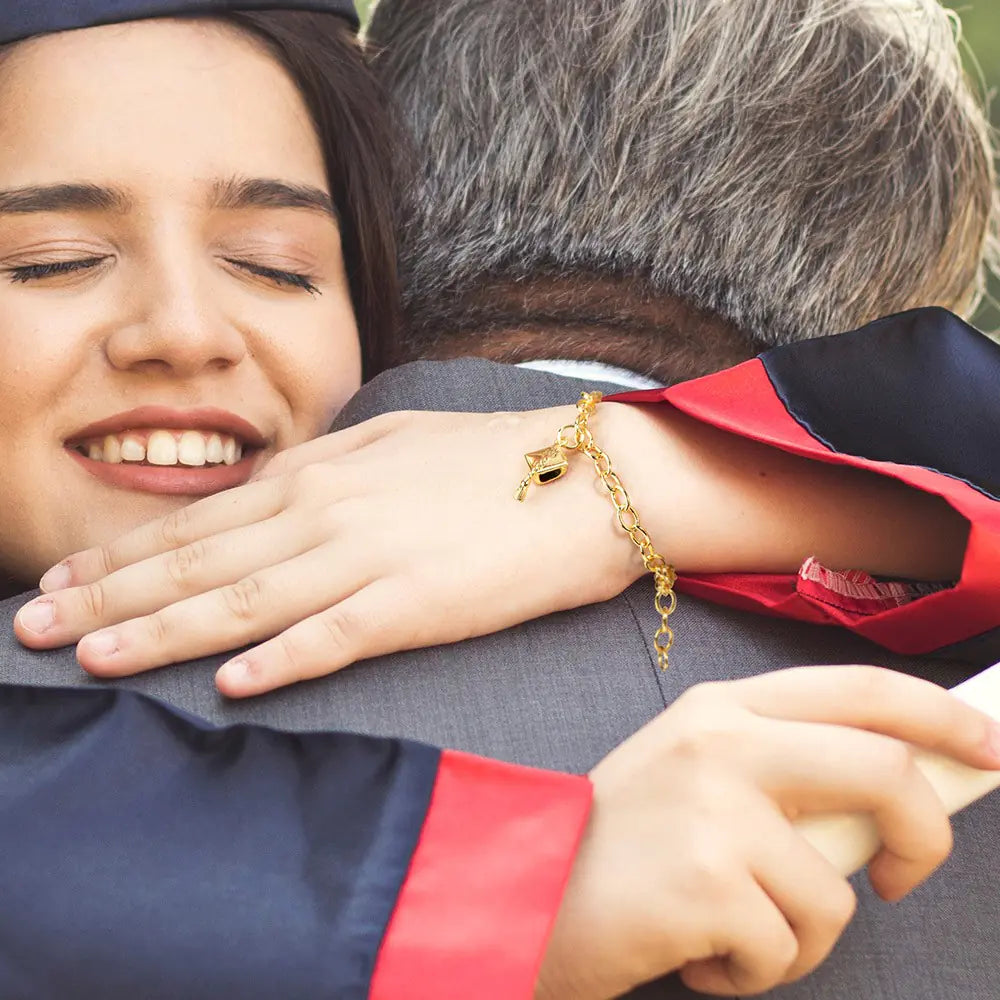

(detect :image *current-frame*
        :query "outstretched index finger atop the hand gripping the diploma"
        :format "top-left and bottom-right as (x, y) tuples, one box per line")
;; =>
(730, 666), (1000, 768)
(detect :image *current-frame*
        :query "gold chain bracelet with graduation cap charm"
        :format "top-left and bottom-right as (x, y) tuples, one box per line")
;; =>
(514, 392), (677, 670)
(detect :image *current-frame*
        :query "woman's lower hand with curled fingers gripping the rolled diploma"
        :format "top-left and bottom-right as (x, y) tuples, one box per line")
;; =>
(536, 667), (1000, 1000)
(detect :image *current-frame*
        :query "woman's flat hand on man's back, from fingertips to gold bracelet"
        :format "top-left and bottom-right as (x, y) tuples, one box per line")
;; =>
(15, 406), (642, 697)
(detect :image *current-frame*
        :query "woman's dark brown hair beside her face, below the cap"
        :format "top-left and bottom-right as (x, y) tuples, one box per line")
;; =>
(221, 11), (401, 377)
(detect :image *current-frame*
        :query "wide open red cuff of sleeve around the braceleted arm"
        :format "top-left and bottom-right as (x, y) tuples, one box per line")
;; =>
(610, 368), (1000, 655)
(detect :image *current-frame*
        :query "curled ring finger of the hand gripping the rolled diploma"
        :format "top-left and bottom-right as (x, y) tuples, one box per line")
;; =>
(752, 803), (857, 982)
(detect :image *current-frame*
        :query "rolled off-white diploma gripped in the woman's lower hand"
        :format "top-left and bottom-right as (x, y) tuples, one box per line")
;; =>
(795, 664), (1000, 875)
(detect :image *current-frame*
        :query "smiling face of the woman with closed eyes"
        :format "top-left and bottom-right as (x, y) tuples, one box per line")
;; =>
(0, 20), (361, 580)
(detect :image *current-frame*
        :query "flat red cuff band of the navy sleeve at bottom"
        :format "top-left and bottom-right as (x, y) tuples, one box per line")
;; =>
(369, 751), (592, 1000)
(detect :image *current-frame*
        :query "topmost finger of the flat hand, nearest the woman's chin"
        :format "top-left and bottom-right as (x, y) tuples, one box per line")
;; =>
(42, 480), (285, 593)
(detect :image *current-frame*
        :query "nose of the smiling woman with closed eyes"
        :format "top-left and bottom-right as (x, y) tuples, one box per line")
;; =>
(104, 252), (247, 378)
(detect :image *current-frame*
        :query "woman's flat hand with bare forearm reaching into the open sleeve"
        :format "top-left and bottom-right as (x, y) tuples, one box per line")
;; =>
(15, 403), (968, 697)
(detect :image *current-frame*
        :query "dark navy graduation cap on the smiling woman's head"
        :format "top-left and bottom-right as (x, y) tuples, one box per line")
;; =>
(0, 0), (358, 45)
